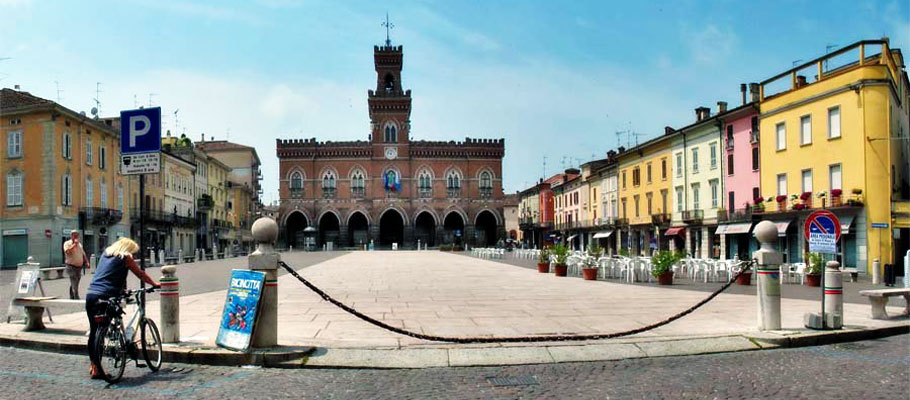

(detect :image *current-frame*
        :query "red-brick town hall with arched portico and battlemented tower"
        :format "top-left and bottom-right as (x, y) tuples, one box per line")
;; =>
(277, 41), (505, 248)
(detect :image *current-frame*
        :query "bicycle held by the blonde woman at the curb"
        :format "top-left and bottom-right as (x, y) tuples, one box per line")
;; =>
(92, 288), (163, 383)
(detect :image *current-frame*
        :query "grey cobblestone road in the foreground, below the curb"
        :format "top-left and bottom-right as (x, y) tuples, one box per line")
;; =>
(0, 335), (910, 400)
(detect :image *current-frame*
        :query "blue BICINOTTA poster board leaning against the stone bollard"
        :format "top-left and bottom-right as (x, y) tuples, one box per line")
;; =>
(215, 269), (265, 351)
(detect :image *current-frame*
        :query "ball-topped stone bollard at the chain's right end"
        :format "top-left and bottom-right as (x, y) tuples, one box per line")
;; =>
(752, 221), (783, 330)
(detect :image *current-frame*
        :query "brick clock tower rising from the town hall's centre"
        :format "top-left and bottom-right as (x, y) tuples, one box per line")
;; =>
(367, 42), (411, 160)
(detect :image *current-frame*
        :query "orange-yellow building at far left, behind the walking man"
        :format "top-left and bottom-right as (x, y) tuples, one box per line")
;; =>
(0, 89), (130, 268)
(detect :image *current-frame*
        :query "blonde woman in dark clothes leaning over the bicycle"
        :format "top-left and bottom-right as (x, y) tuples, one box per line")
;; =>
(85, 237), (160, 379)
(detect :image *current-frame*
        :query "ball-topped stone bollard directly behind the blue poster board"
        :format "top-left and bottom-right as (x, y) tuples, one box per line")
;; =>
(249, 217), (281, 347)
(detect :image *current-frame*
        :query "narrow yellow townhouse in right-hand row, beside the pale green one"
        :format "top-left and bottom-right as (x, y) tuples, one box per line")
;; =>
(614, 134), (673, 255)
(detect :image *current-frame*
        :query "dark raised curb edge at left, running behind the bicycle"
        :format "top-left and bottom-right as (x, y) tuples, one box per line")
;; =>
(0, 336), (316, 367)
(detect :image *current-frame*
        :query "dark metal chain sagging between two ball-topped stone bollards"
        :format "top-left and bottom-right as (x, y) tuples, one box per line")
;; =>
(278, 260), (757, 343)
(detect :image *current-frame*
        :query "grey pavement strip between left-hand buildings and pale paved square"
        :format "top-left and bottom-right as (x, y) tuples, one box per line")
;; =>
(0, 251), (347, 321)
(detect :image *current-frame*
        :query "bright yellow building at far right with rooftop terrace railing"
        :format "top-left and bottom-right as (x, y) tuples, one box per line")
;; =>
(760, 39), (910, 271)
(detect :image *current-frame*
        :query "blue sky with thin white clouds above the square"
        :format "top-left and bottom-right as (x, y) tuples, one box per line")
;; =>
(0, 0), (910, 203)
